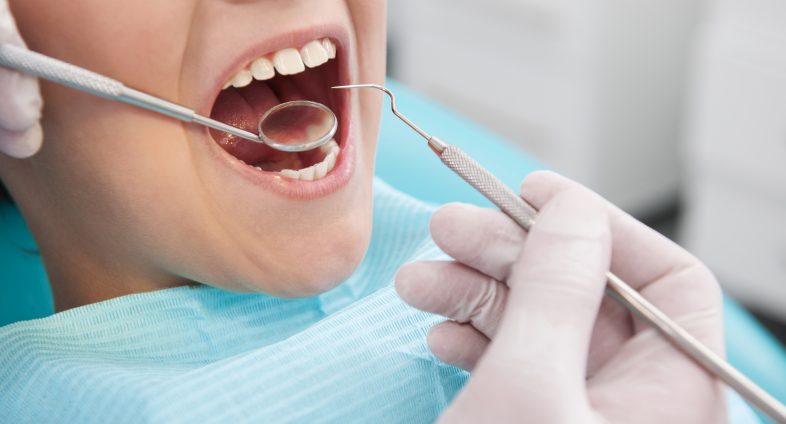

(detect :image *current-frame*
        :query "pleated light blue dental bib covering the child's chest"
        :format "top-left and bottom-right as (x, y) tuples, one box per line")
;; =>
(0, 181), (749, 423)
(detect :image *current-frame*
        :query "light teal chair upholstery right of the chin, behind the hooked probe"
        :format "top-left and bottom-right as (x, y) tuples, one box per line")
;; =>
(377, 82), (786, 420)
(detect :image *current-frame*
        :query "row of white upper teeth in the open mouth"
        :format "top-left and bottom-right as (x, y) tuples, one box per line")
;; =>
(224, 38), (336, 89)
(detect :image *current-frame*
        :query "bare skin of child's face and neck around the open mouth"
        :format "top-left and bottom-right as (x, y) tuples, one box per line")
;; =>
(0, 0), (386, 310)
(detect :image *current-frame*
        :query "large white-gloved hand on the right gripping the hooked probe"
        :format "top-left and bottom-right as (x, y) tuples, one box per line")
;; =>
(396, 172), (726, 423)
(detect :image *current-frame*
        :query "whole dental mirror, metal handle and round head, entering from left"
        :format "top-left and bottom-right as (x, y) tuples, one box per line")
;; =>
(0, 44), (338, 152)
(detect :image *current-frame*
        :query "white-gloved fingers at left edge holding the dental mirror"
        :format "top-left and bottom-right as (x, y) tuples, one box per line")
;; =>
(0, 0), (43, 158)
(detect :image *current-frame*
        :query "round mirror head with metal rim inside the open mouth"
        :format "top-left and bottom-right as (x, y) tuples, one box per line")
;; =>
(254, 100), (338, 152)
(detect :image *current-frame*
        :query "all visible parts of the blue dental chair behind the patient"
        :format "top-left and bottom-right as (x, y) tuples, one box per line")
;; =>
(0, 82), (786, 422)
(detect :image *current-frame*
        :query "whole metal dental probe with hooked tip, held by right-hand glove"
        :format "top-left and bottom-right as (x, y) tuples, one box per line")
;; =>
(333, 84), (786, 423)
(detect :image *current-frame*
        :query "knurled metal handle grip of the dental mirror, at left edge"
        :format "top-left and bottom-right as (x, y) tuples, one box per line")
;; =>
(0, 44), (124, 99)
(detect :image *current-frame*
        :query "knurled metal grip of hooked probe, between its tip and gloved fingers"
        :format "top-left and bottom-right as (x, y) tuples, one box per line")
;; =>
(439, 145), (537, 231)
